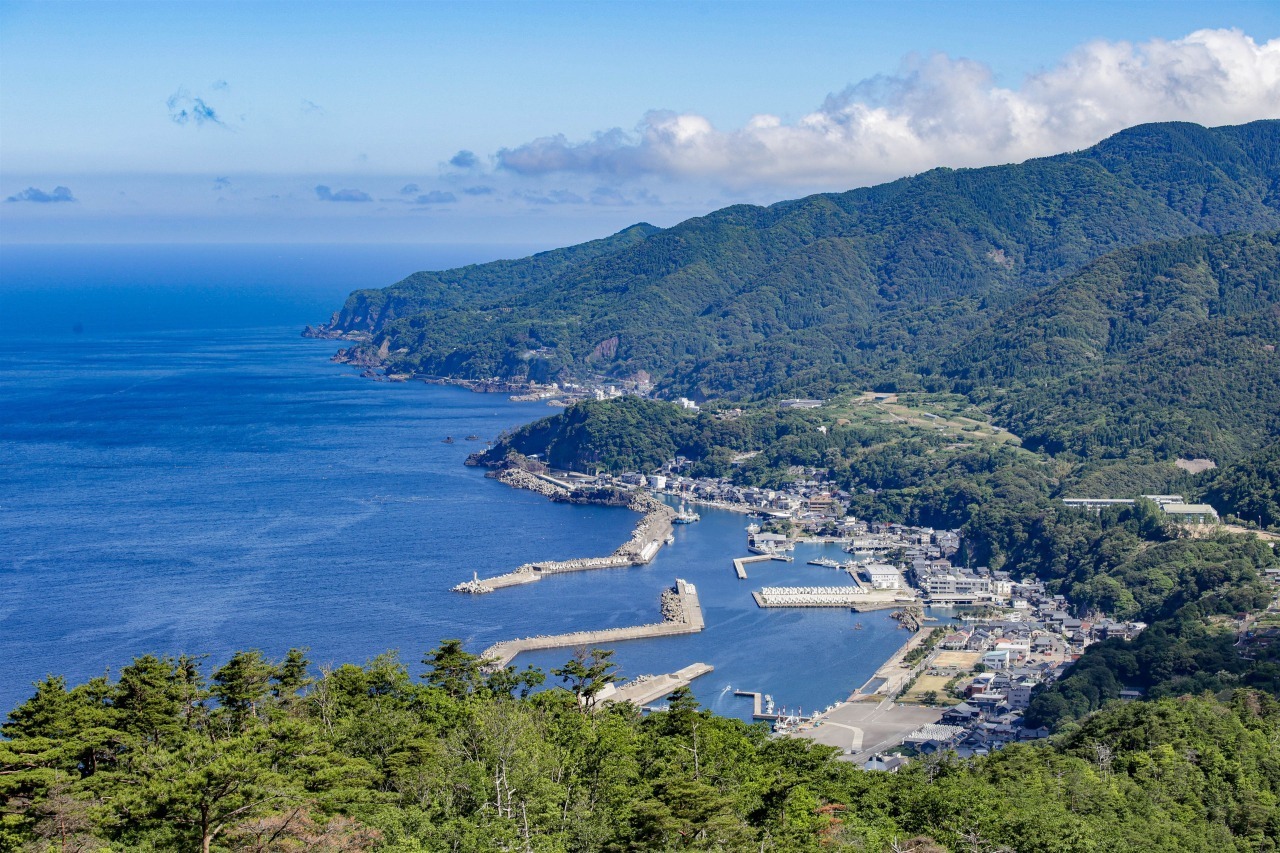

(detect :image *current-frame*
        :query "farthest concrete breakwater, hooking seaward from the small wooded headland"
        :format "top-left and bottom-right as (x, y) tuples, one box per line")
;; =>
(453, 479), (676, 596)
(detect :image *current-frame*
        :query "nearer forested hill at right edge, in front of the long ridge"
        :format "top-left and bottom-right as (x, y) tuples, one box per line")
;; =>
(952, 232), (1280, 460)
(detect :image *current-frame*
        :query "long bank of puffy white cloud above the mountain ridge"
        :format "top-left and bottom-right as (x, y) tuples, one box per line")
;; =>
(498, 29), (1280, 187)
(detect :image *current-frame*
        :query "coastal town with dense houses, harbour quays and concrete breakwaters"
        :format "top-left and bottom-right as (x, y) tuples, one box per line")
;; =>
(454, 450), (1217, 770)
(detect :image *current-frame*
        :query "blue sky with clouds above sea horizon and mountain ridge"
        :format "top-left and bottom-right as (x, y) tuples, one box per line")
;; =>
(0, 0), (1280, 245)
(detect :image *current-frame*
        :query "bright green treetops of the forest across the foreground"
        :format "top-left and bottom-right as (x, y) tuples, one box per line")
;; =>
(0, 640), (1280, 853)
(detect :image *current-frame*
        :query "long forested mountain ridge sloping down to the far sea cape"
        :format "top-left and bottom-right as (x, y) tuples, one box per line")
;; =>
(309, 120), (1280, 397)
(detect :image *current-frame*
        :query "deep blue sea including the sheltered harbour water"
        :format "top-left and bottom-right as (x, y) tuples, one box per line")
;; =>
(0, 246), (905, 719)
